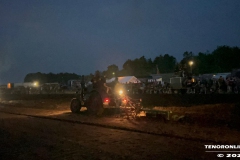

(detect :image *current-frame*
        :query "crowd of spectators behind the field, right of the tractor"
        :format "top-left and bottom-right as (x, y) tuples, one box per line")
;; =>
(118, 76), (240, 94)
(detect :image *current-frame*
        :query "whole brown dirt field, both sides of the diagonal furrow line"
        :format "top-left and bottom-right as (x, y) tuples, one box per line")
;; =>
(0, 94), (239, 159)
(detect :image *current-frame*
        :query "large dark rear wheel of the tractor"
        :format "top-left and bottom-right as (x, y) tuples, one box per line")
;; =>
(87, 92), (104, 116)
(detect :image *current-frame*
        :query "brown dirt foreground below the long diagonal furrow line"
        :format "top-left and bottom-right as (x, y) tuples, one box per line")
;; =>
(0, 113), (219, 160)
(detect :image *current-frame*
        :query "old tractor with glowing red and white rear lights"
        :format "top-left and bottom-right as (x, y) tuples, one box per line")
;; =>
(70, 76), (141, 116)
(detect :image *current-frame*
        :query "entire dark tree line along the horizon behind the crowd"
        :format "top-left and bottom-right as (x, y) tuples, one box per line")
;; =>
(24, 46), (240, 83)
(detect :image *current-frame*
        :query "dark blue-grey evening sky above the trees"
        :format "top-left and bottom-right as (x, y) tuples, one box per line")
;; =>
(0, 0), (240, 84)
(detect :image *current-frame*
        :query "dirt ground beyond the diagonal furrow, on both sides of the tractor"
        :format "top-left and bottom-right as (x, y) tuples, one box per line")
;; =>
(1, 98), (240, 144)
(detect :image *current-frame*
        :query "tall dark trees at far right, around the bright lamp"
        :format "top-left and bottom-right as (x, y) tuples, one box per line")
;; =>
(180, 46), (240, 75)
